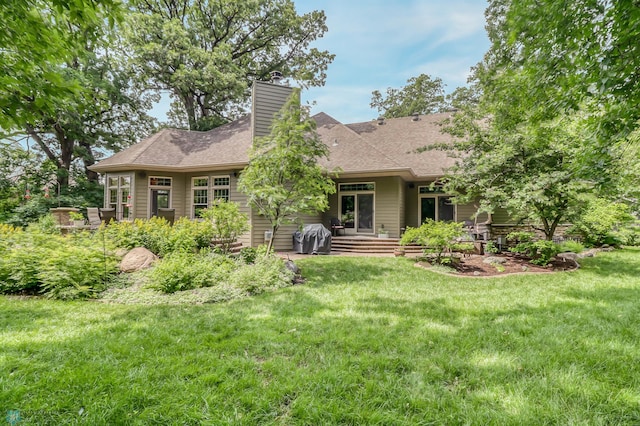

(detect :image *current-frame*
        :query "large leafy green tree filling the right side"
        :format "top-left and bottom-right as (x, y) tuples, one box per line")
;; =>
(438, 0), (640, 239)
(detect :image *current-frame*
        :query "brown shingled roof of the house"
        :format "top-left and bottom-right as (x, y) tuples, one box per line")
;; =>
(92, 113), (460, 179)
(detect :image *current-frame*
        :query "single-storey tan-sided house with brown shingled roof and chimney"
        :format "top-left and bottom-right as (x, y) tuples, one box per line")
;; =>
(91, 82), (506, 250)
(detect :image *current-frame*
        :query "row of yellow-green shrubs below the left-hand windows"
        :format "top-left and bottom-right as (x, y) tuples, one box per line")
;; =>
(101, 217), (214, 257)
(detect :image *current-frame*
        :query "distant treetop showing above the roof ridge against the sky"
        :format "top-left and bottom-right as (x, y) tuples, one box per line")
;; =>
(370, 74), (446, 118)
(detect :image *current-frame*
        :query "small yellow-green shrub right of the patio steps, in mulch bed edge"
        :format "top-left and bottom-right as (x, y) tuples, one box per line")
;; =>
(400, 218), (464, 263)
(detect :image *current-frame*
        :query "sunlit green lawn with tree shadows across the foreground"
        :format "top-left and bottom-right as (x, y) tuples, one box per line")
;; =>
(0, 249), (640, 425)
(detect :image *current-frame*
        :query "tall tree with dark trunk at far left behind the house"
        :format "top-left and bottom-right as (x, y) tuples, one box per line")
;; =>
(0, 0), (153, 188)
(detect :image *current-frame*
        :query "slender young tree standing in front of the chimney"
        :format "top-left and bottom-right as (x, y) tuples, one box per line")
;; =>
(238, 90), (336, 251)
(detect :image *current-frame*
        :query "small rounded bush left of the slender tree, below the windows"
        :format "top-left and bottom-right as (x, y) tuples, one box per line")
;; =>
(202, 200), (249, 253)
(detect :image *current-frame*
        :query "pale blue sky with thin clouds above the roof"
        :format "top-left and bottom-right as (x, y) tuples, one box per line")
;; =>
(154, 0), (489, 123)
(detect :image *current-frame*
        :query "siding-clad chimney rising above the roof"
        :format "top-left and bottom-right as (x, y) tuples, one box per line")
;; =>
(251, 81), (294, 138)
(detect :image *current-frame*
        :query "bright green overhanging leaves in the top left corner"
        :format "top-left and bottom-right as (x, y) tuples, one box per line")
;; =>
(0, 0), (121, 129)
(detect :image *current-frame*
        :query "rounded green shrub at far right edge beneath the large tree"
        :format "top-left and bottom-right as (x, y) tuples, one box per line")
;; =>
(569, 198), (635, 246)
